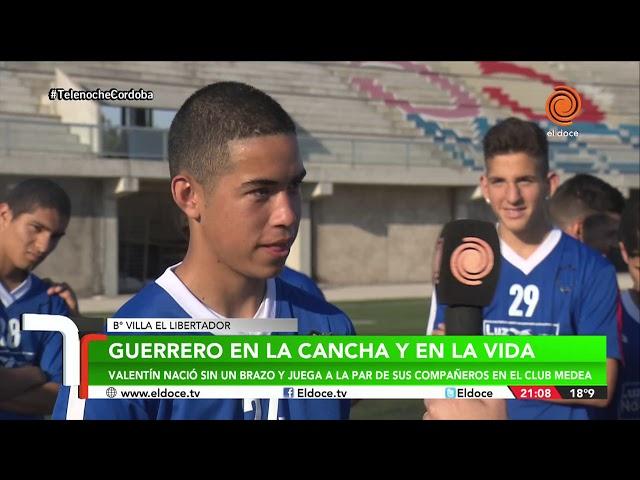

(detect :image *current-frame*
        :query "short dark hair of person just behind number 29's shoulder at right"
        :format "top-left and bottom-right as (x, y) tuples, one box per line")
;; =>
(549, 173), (624, 228)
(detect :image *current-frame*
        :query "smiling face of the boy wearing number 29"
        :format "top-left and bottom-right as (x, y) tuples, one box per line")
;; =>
(480, 152), (550, 234)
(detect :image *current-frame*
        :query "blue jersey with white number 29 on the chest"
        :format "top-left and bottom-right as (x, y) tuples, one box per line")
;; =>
(427, 229), (621, 420)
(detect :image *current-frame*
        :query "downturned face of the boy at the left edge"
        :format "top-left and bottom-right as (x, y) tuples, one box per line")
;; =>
(0, 203), (69, 271)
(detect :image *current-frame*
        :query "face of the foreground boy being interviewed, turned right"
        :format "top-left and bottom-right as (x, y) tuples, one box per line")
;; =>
(201, 135), (305, 278)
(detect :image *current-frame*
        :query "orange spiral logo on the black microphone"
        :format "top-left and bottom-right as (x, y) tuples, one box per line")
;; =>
(450, 237), (494, 285)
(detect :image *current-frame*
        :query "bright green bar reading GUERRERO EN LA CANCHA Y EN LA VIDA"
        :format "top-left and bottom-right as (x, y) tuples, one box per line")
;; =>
(89, 335), (606, 368)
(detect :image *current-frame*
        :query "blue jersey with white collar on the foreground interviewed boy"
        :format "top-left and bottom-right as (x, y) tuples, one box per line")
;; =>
(53, 267), (355, 420)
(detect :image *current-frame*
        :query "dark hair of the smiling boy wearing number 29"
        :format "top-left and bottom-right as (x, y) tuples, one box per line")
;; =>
(483, 117), (549, 177)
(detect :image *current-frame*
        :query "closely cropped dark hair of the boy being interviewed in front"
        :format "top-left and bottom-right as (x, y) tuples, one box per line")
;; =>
(169, 82), (296, 186)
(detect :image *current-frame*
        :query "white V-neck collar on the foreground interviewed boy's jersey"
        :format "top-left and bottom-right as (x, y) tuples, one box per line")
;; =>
(156, 262), (276, 319)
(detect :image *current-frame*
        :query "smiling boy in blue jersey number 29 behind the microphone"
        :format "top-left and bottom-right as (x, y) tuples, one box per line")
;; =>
(427, 118), (621, 419)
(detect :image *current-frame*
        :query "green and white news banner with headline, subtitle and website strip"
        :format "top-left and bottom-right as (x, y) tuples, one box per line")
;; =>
(80, 334), (606, 400)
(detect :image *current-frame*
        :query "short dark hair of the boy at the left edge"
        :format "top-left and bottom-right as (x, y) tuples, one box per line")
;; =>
(4, 178), (71, 218)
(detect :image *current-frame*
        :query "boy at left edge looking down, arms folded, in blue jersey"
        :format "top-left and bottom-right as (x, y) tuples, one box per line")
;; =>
(0, 179), (71, 420)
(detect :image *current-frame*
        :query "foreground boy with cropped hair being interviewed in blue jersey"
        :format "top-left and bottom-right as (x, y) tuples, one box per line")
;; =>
(54, 82), (355, 420)
